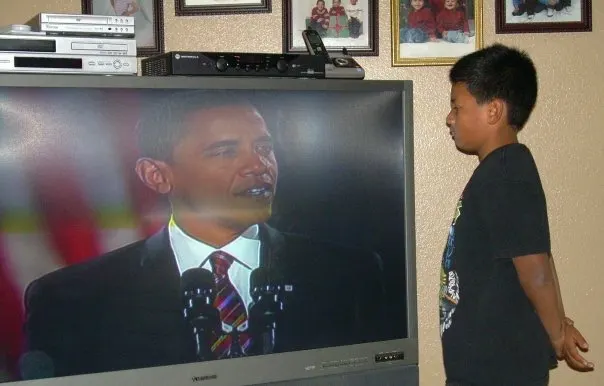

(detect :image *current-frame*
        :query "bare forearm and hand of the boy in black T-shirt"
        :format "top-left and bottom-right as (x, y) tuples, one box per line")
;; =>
(513, 253), (594, 371)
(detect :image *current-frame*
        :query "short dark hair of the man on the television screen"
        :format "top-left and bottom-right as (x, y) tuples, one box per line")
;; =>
(137, 90), (255, 162)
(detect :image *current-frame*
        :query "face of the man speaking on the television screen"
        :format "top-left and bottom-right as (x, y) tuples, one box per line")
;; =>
(169, 106), (278, 227)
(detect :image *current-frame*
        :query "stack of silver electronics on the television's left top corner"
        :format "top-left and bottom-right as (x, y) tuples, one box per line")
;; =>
(0, 13), (138, 75)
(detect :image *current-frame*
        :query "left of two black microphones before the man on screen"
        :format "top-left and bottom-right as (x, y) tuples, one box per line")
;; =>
(181, 268), (221, 361)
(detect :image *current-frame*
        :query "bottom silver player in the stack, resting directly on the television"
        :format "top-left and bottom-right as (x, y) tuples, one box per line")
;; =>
(0, 52), (138, 75)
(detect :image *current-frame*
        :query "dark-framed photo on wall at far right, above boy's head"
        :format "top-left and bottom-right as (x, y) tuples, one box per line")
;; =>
(495, 0), (592, 34)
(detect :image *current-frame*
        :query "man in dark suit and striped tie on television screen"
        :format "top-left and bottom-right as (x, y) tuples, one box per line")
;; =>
(25, 91), (396, 376)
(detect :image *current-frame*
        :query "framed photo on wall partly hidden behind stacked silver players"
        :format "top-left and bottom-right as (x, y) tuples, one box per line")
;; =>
(82, 0), (164, 57)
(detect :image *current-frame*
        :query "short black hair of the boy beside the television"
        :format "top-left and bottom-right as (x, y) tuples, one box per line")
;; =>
(449, 44), (537, 131)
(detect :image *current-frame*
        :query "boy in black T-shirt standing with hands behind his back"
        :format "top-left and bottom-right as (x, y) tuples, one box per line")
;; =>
(440, 44), (594, 386)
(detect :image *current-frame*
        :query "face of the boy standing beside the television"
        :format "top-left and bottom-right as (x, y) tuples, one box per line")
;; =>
(447, 83), (489, 154)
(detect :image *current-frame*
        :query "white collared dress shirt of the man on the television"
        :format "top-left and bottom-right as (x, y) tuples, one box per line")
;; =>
(168, 220), (260, 311)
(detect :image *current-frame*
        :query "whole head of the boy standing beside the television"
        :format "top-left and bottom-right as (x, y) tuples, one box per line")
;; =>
(447, 44), (537, 158)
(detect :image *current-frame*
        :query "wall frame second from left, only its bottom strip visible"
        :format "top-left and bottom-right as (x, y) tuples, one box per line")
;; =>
(174, 0), (272, 16)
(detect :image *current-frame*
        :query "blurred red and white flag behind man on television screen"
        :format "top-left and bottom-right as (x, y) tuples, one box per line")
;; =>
(0, 89), (163, 380)
